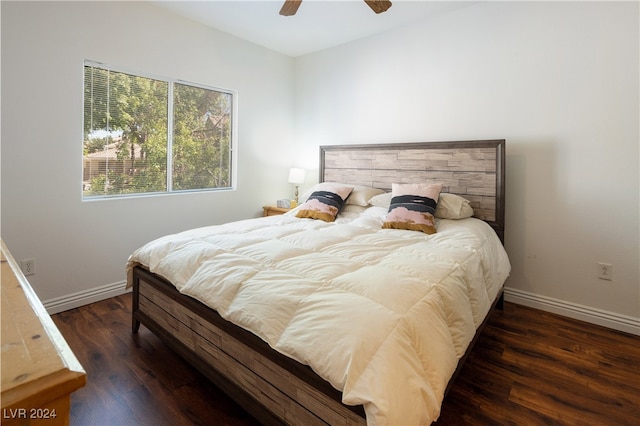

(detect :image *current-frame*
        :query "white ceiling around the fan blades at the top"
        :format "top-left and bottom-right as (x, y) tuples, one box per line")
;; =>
(152, 0), (475, 57)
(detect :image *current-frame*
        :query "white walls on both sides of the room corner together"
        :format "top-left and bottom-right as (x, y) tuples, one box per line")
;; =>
(1, 2), (640, 332)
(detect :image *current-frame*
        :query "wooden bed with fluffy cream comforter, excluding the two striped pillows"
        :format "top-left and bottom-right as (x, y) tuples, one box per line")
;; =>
(127, 140), (510, 425)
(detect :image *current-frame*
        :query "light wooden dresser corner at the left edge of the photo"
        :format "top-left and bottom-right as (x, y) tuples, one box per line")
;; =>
(0, 241), (87, 426)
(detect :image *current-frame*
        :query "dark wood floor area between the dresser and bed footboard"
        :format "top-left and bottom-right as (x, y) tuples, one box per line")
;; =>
(53, 294), (257, 426)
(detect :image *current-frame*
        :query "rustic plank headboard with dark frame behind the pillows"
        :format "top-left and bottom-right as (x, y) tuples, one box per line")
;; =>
(320, 139), (505, 243)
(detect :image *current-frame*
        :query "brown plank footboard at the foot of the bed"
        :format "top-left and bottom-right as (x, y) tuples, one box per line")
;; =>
(132, 267), (366, 425)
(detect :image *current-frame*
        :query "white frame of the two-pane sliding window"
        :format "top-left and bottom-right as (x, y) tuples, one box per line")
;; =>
(80, 60), (238, 202)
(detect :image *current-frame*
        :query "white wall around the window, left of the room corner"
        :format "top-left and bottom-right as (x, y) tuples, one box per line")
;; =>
(1, 1), (295, 310)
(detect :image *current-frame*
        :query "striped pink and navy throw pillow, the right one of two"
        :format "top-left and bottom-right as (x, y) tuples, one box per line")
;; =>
(382, 183), (442, 234)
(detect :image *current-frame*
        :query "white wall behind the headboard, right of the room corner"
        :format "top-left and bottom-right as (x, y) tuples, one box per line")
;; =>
(295, 2), (640, 334)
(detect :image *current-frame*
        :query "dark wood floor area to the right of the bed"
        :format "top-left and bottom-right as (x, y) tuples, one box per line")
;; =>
(437, 303), (640, 426)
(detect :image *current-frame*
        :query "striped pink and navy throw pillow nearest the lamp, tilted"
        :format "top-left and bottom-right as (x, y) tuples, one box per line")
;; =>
(296, 182), (353, 222)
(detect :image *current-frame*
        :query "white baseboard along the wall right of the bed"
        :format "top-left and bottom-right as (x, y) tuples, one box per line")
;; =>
(504, 287), (640, 336)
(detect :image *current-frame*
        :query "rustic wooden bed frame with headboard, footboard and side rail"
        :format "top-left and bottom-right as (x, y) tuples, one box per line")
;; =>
(132, 140), (505, 425)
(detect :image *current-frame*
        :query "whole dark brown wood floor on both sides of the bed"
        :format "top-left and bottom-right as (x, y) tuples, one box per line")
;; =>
(53, 294), (640, 426)
